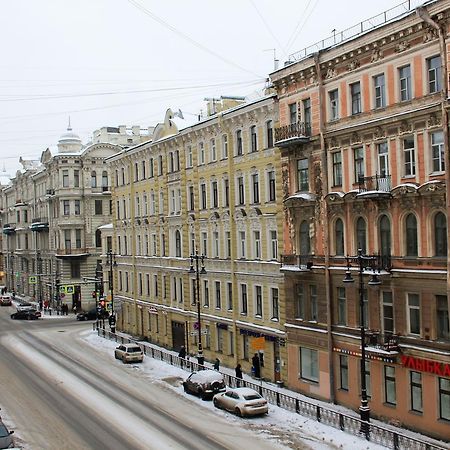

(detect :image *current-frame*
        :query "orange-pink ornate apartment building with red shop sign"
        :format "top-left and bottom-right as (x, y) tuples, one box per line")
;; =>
(271, 1), (450, 438)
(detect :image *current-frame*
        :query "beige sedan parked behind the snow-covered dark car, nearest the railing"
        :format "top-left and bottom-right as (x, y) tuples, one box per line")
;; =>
(213, 388), (269, 417)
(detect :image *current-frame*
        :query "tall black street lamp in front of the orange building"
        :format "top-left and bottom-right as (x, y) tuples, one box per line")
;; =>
(343, 249), (381, 436)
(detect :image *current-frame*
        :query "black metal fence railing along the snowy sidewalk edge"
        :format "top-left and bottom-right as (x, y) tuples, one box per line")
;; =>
(93, 323), (450, 450)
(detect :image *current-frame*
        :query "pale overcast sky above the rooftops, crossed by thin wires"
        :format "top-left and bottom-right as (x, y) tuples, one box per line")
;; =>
(0, 0), (420, 175)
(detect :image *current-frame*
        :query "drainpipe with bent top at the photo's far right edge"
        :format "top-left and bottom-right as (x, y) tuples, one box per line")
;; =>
(416, 7), (450, 318)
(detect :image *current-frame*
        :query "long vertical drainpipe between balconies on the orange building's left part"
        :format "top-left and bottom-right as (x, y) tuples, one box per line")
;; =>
(314, 53), (335, 403)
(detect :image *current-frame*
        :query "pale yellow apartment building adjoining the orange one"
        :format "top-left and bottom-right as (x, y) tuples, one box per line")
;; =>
(105, 95), (287, 380)
